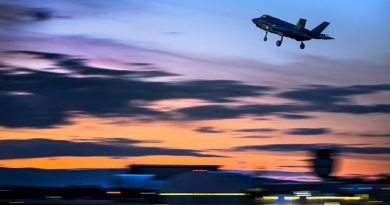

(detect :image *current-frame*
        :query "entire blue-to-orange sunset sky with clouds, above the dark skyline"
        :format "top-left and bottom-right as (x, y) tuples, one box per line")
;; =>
(0, 0), (390, 177)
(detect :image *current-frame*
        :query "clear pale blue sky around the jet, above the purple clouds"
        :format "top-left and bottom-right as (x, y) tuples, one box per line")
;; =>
(6, 0), (390, 63)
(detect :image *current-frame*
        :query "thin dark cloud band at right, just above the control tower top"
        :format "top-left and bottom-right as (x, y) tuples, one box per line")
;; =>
(233, 144), (390, 154)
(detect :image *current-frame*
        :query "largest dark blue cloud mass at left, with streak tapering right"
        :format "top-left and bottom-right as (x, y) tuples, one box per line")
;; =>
(0, 51), (272, 127)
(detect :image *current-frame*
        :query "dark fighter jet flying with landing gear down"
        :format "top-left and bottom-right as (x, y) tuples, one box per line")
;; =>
(252, 15), (334, 49)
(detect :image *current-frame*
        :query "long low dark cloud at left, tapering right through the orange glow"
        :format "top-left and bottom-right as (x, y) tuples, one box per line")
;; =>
(0, 139), (218, 159)
